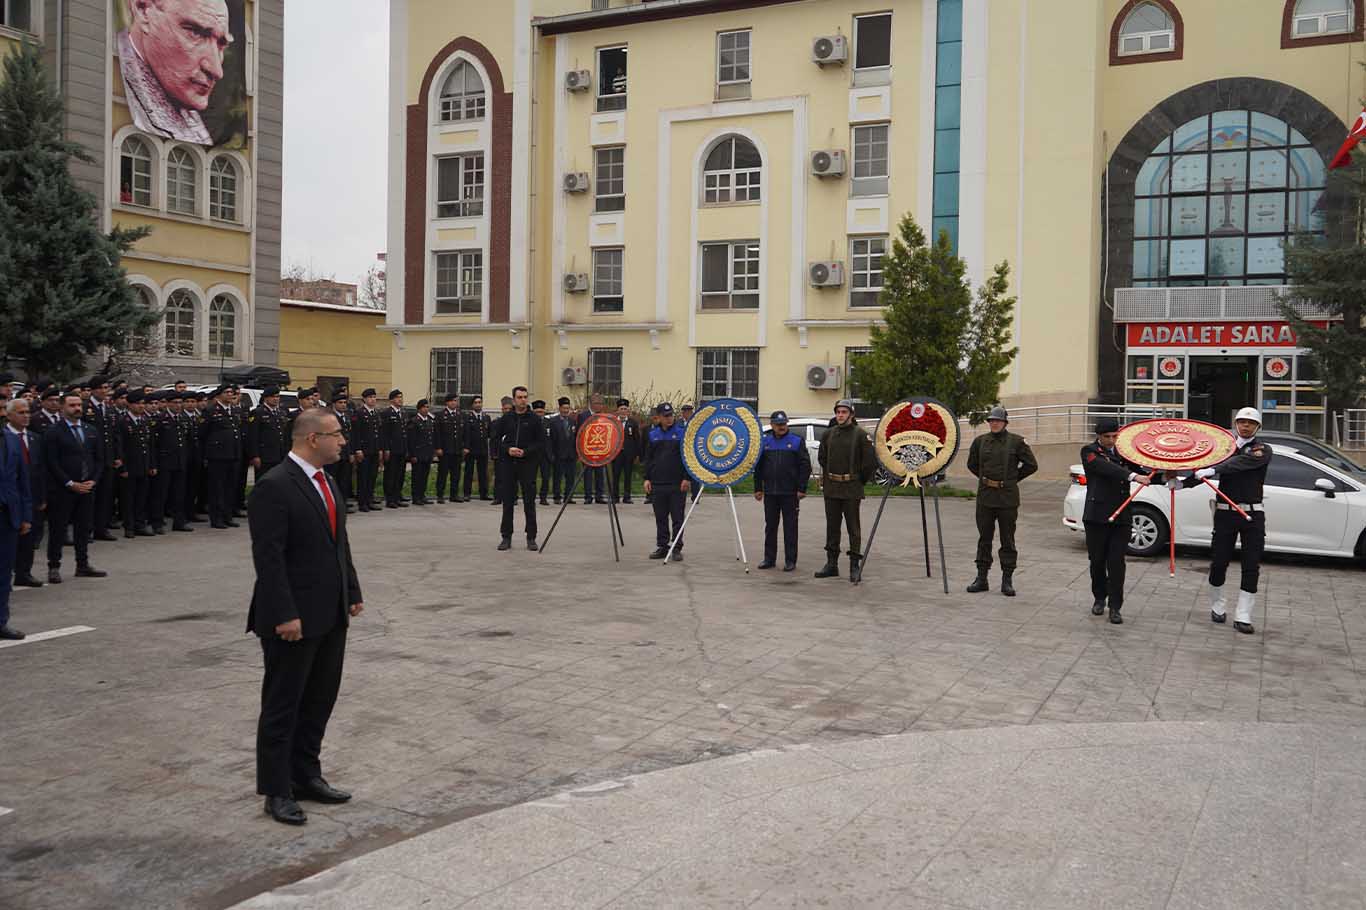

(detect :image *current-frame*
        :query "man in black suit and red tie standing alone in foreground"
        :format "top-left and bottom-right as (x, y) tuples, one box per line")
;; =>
(247, 409), (363, 825)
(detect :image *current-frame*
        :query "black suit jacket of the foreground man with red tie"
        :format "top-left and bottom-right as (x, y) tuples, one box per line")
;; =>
(247, 458), (363, 638)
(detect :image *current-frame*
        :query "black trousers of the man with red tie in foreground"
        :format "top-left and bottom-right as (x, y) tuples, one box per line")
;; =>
(257, 624), (346, 797)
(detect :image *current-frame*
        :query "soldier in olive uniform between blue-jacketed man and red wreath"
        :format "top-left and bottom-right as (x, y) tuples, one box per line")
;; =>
(816, 398), (877, 581)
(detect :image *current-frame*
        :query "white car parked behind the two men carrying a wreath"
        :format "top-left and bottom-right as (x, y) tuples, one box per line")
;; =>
(1063, 445), (1366, 559)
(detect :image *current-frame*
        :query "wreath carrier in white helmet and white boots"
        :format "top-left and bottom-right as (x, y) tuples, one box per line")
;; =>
(1183, 407), (1272, 635)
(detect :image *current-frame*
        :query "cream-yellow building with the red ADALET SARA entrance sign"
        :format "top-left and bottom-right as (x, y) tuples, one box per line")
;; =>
(385, 0), (1363, 432)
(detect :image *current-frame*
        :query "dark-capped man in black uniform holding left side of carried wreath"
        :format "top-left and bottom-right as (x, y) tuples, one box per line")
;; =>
(1082, 417), (1162, 626)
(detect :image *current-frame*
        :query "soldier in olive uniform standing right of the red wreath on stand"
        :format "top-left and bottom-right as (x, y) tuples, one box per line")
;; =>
(967, 406), (1038, 597)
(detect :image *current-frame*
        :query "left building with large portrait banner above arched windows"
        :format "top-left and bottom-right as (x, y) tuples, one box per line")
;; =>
(0, 0), (284, 384)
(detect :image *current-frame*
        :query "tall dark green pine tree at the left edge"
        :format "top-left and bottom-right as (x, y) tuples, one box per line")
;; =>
(0, 42), (158, 378)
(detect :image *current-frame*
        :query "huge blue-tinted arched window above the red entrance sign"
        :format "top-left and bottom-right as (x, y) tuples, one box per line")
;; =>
(1134, 111), (1328, 287)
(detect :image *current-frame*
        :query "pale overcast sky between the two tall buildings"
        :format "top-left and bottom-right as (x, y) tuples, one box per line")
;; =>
(280, 0), (389, 281)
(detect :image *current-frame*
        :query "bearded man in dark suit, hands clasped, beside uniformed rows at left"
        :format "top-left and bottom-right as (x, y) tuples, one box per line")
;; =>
(42, 395), (113, 585)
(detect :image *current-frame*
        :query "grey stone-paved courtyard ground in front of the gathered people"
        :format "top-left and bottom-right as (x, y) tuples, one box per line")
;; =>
(0, 484), (1366, 910)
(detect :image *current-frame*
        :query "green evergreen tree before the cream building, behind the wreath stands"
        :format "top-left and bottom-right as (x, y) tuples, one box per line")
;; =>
(854, 215), (1019, 415)
